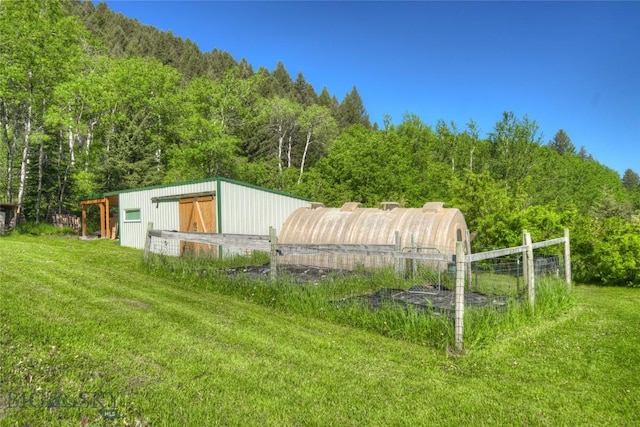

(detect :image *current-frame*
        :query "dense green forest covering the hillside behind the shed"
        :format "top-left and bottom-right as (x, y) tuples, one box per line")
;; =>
(0, 0), (640, 286)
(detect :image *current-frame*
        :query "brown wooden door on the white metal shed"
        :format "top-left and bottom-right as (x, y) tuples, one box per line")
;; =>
(179, 196), (218, 255)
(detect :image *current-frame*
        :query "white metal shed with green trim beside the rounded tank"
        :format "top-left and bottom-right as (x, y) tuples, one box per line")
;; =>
(81, 177), (311, 254)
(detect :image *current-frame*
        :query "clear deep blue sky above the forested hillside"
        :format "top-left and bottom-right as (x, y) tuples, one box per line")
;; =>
(106, 0), (640, 175)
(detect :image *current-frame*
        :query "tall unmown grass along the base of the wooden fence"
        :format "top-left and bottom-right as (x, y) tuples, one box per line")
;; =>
(145, 253), (573, 349)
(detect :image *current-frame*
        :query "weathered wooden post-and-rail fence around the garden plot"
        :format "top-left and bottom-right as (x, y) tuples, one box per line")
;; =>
(144, 223), (571, 352)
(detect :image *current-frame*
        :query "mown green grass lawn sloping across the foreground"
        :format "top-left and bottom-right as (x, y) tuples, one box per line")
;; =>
(0, 236), (640, 426)
